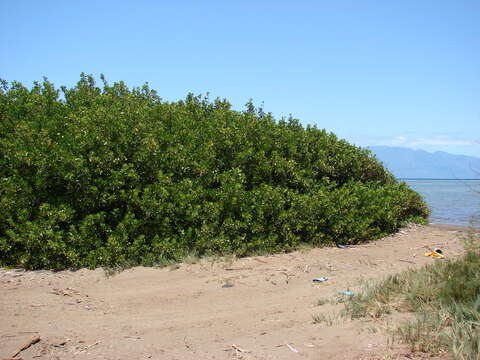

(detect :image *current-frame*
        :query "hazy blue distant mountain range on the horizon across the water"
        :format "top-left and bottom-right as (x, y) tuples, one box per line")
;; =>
(369, 146), (480, 179)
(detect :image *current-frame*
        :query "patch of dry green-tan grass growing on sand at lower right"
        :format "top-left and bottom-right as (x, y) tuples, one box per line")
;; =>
(340, 231), (480, 360)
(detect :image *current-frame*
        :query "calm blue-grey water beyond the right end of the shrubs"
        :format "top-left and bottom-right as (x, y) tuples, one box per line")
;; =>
(403, 180), (480, 227)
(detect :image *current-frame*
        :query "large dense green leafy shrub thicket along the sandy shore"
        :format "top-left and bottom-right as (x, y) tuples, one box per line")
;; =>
(0, 74), (428, 269)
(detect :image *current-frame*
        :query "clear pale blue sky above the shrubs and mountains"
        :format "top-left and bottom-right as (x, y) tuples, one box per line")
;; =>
(0, 0), (480, 157)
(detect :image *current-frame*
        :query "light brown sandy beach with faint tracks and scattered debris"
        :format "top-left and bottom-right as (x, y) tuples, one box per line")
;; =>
(0, 225), (466, 360)
